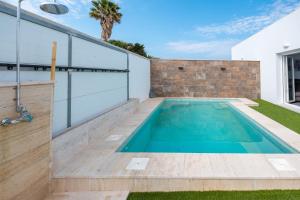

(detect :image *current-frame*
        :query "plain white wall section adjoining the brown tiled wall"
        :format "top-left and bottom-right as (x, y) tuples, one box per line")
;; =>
(129, 54), (150, 101)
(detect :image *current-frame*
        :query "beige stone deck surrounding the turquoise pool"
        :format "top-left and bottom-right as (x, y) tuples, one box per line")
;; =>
(52, 98), (300, 193)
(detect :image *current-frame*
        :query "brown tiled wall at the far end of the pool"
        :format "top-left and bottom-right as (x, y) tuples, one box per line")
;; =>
(151, 59), (260, 99)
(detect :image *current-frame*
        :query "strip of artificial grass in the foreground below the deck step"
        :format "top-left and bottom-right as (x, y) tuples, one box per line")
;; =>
(127, 190), (300, 200)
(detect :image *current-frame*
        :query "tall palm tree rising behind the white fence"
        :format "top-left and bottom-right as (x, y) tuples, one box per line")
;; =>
(90, 0), (122, 41)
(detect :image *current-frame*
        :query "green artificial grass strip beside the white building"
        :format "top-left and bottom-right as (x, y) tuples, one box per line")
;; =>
(252, 99), (300, 134)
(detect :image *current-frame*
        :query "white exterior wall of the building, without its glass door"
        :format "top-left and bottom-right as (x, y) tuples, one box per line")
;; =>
(232, 9), (300, 103)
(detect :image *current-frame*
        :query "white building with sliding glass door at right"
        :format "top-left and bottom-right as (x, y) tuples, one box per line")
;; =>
(232, 9), (300, 111)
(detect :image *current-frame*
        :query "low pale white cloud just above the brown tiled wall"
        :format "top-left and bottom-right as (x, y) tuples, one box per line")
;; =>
(167, 39), (238, 57)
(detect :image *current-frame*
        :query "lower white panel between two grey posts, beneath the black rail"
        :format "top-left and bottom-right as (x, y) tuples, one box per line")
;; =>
(72, 72), (127, 124)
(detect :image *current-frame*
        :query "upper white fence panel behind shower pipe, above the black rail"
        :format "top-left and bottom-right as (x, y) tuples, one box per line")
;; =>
(0, 13), (68, 66)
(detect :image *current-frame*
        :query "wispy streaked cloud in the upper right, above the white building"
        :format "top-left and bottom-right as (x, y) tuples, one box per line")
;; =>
(197, 0), (300, 35)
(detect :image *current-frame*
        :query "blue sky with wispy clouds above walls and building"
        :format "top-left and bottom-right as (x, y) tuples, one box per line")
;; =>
(4, 0), (300, 59)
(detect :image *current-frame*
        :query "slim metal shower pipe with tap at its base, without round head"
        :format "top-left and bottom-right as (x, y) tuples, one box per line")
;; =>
(0, 0), (33, 126)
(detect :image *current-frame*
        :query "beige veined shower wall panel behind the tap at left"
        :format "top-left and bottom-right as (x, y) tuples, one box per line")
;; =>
(0, 83), (53, 200)
